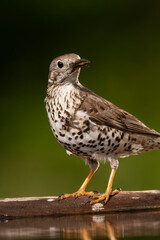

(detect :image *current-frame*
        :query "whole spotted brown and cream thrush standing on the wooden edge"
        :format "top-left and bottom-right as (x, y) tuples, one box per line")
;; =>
(45, 53), (160, 204)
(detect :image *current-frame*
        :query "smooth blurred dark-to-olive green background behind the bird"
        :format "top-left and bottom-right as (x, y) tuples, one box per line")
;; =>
(0, 0), (160, 197)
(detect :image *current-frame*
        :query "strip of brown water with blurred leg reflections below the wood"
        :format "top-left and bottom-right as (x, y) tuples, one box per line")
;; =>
(0, 211), (160, 240)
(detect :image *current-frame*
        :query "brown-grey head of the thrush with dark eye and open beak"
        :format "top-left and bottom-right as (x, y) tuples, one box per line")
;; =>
(48, 53), (89, 86)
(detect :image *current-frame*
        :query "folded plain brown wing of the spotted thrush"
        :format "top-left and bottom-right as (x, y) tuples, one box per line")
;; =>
(79, 89), (160, 136)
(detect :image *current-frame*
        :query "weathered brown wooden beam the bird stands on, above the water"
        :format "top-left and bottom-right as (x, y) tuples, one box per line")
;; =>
(0, 190), (160, 219)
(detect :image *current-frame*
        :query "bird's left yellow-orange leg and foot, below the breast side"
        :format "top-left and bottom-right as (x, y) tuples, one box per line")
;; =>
(60, 171), (95, 199)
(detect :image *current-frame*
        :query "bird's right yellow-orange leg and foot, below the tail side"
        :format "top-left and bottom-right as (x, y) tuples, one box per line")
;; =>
(90, 168), (120, 204)
